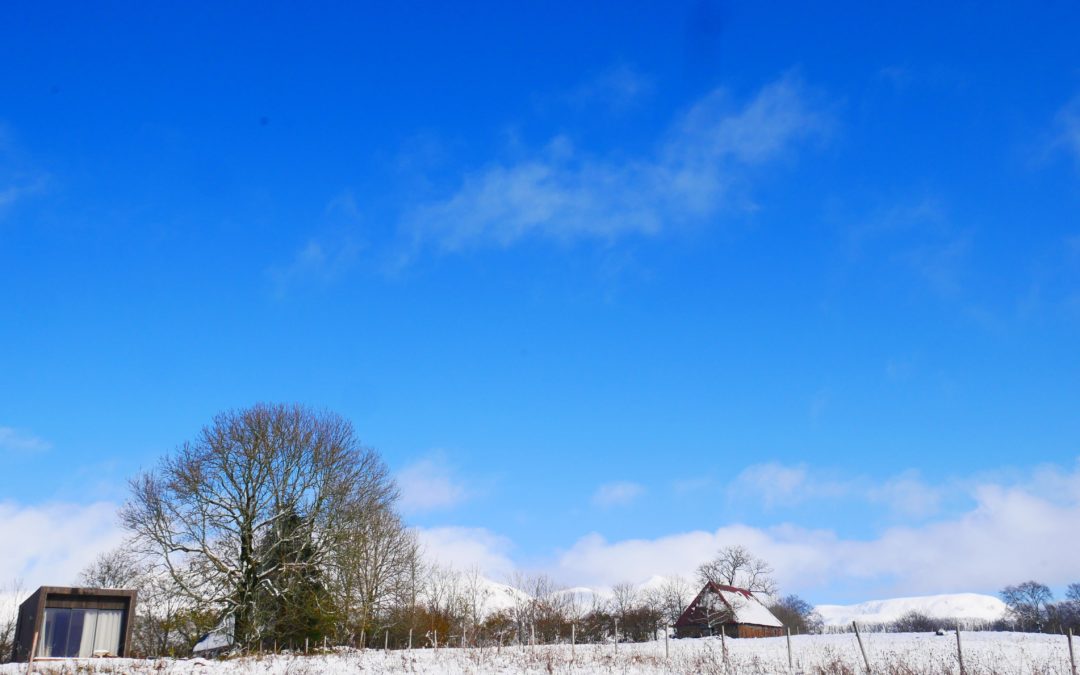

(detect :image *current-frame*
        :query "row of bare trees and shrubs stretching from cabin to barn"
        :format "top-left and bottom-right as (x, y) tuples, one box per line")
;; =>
(6, 404), (816, 656)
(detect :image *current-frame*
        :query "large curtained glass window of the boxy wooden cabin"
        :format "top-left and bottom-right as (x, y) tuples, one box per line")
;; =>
(37, 607), (123, 659)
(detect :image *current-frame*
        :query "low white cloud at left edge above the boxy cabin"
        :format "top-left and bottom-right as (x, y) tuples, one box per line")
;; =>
(0, 502), (124, 589)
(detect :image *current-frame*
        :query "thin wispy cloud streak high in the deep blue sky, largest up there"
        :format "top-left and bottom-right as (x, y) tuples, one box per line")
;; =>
(406, 76), (827, 251)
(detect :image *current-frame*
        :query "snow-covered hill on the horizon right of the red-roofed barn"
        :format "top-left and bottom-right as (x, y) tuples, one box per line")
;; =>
(816, 593), (1005, 625)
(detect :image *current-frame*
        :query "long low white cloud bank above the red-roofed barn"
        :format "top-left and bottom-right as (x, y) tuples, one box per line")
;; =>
(554, 457), (1080, 597)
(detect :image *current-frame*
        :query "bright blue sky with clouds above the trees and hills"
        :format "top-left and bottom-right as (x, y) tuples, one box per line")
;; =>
(0, 2), (1080, 602)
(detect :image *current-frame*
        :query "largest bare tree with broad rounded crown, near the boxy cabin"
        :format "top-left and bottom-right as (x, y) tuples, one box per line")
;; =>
(121, 404), (395, 646)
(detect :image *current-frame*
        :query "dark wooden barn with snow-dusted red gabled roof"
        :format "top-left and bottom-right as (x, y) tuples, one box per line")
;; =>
(675, 583), (784, 637)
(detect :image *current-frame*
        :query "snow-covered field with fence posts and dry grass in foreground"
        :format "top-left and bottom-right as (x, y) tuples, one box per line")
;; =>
(0, 633), (1070, 675)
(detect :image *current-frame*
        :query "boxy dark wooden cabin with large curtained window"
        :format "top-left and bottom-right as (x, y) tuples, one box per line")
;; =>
(12, 586), (136, 662)
